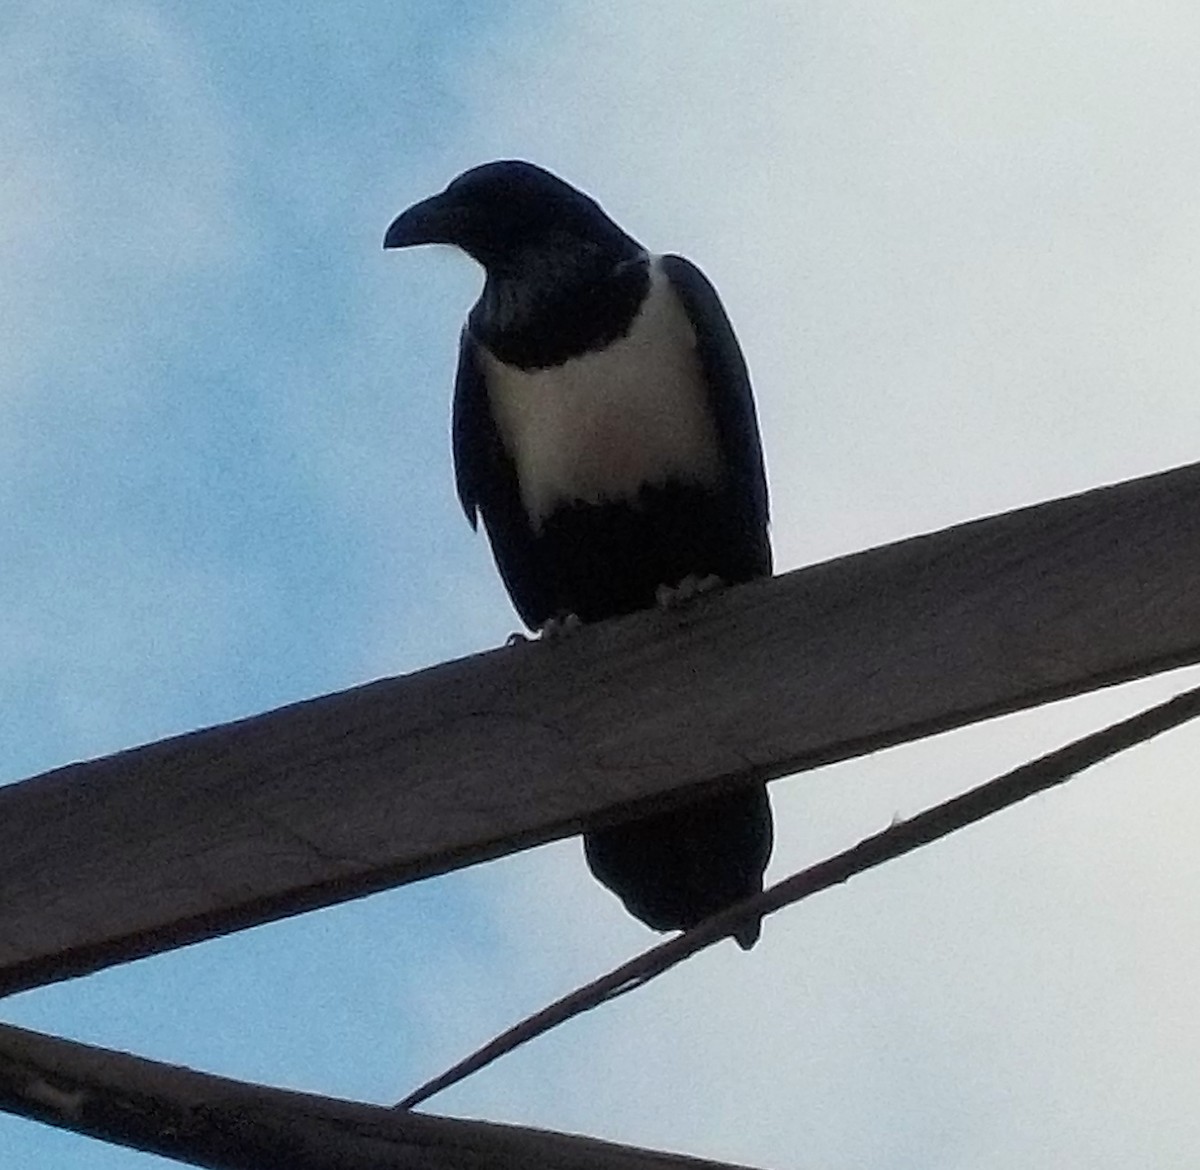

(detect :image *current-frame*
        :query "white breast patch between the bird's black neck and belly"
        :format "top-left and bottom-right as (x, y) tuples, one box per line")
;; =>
(481, 258), (721, 526)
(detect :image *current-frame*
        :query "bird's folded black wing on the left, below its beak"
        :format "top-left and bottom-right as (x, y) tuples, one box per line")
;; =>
(451, 329), (553, 629)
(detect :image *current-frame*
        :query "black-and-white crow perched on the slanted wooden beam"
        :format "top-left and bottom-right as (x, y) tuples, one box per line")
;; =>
(384, 160), (773, 950)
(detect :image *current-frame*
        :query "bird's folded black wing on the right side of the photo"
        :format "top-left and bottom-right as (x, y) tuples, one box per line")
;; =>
(661, 256), (772, 576)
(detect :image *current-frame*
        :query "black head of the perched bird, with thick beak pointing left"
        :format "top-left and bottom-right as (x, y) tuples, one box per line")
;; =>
(383, 160), (641, 277)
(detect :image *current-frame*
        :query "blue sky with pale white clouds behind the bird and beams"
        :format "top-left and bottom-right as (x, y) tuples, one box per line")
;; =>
(0, 0), (1200, 1170)
